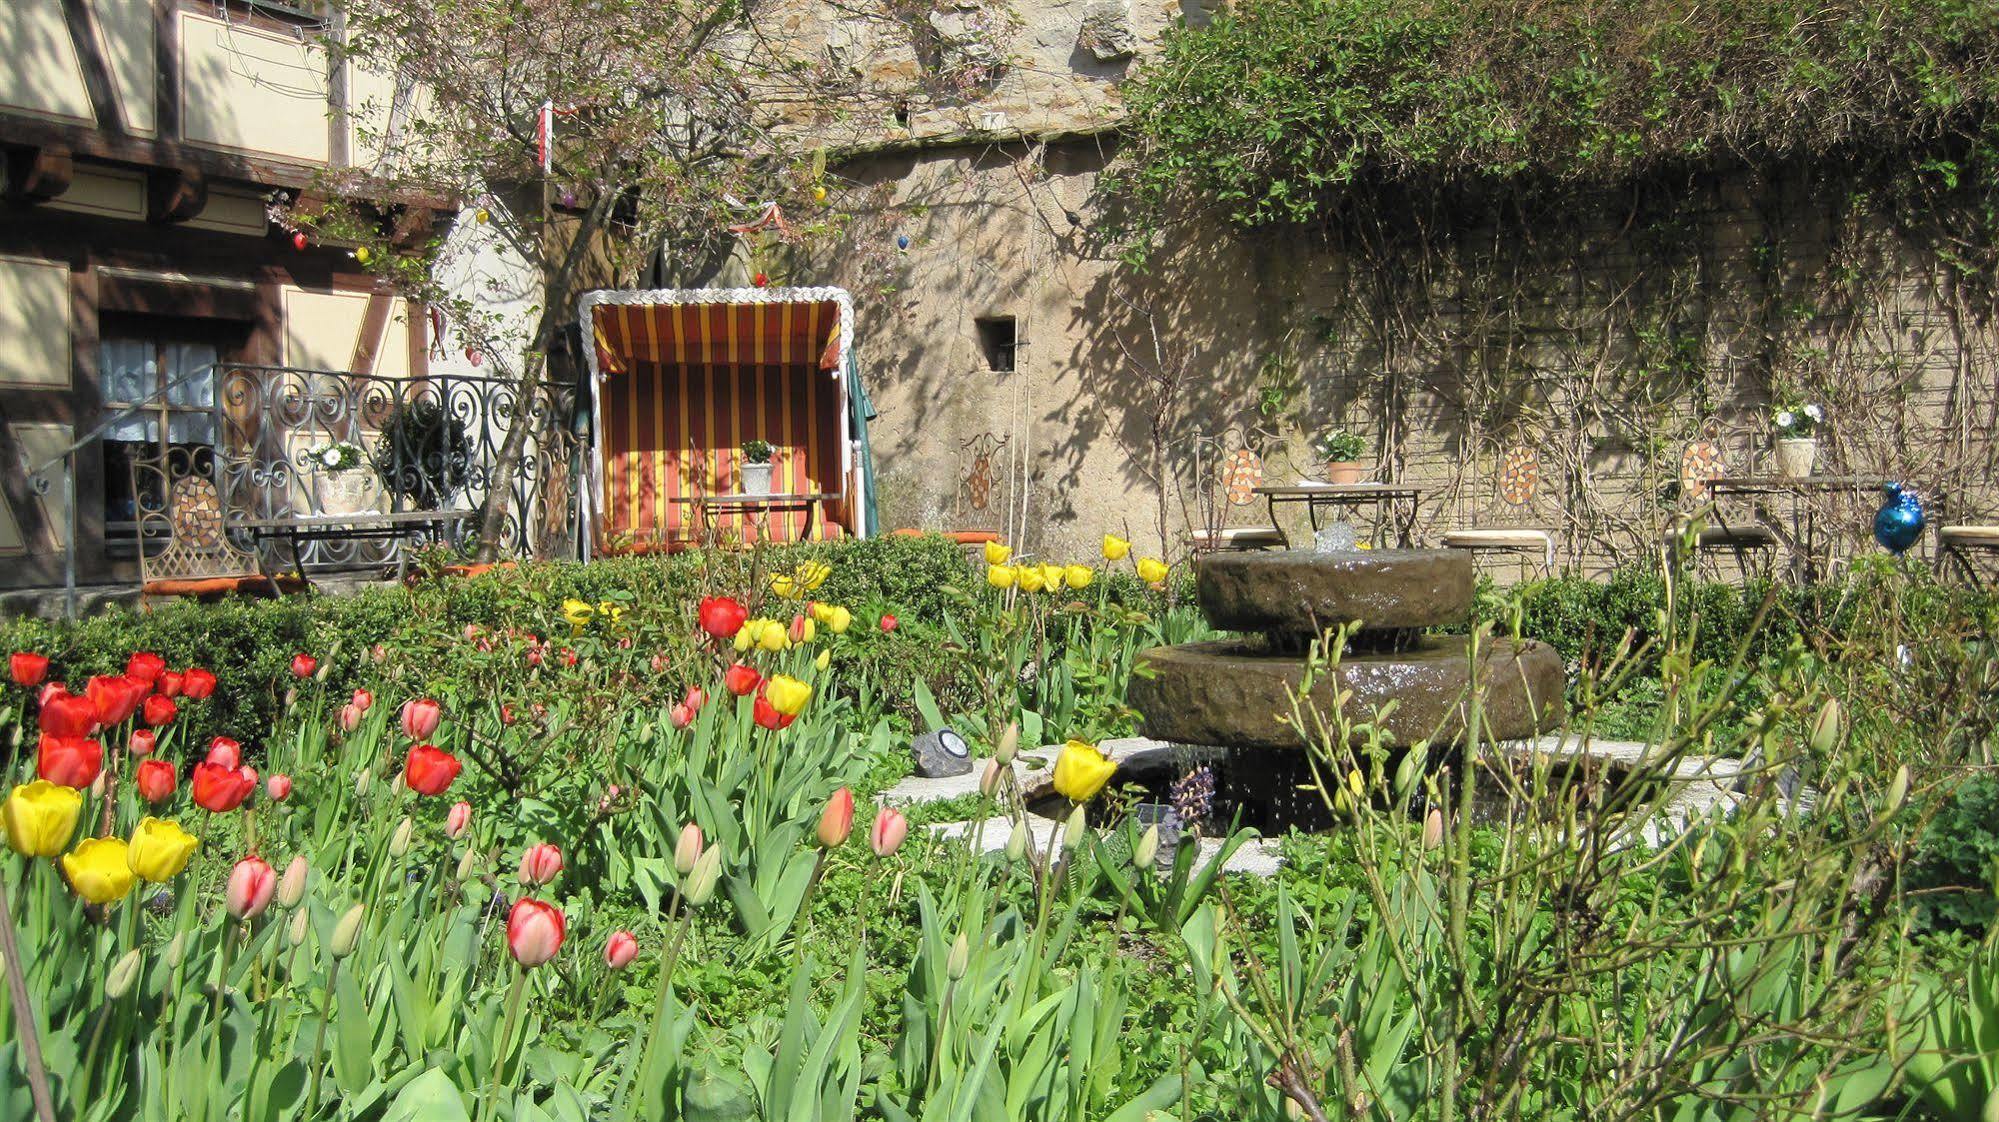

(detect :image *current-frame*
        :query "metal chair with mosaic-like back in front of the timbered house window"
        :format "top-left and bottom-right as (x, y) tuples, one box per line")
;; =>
(130, 446), (306, 606)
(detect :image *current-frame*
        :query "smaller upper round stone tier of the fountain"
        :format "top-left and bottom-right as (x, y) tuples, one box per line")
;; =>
(1193, 550), (1473, 636)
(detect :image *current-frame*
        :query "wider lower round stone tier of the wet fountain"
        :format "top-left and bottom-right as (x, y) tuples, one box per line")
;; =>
(1127, 636), (1563, 748)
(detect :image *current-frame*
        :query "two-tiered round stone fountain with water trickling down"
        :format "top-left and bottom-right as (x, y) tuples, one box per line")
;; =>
(1129, 550), (1563, 830)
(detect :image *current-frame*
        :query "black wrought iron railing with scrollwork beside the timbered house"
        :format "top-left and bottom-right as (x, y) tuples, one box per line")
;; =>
(216, 366), (578, 568)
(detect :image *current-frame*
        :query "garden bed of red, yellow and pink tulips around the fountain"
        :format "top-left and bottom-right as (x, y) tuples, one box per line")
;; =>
(0, 538), (1999, 1122)
